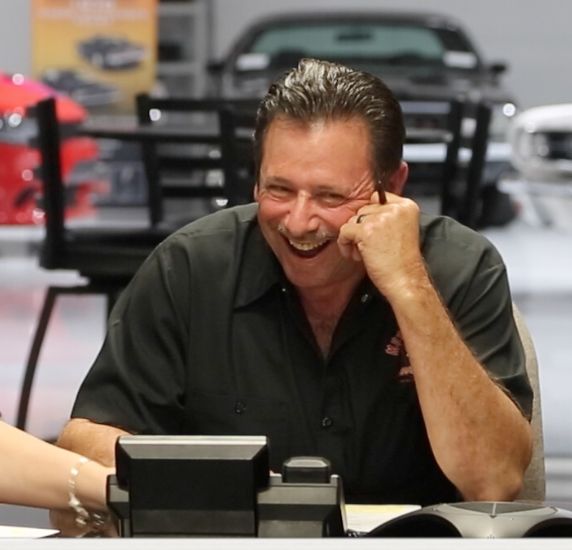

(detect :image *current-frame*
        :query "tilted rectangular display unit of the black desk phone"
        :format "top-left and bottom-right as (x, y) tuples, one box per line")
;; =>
(107, 435), (269, 537)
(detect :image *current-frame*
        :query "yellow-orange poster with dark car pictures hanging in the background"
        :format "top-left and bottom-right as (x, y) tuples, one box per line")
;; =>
(32, 0), (157, 113)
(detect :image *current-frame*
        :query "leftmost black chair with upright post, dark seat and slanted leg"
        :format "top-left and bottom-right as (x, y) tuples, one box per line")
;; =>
(16, 98), (168, 429)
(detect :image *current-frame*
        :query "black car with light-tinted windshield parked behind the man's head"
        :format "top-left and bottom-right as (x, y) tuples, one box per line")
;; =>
(209, 11), (516, 223)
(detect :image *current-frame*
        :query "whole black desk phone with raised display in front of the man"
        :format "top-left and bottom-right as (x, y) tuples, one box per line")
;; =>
(107, 435), (346, 537)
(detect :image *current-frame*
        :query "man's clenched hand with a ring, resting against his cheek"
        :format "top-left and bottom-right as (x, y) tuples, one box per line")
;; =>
(338, 192), (425, 296)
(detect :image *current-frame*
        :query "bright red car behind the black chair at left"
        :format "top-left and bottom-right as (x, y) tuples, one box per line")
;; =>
(0, 73), (105, 224)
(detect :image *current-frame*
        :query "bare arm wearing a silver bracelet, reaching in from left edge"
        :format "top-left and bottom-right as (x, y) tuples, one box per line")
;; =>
(0, 422), (113, 510)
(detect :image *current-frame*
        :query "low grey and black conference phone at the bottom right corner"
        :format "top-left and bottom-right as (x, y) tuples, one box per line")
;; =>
(366, 502), (572, 538)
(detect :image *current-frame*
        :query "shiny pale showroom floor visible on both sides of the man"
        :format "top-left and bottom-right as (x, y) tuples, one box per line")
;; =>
(0, 194), (572, 527)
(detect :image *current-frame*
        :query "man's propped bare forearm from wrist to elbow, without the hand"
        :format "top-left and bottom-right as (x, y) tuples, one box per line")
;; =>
(390, 266), (532, 500)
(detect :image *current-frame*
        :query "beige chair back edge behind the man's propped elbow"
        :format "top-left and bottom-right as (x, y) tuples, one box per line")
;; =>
(513, 304), (546, 501)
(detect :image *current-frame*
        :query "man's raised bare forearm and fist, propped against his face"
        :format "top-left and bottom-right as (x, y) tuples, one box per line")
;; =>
(340, 193), (532, 500)
